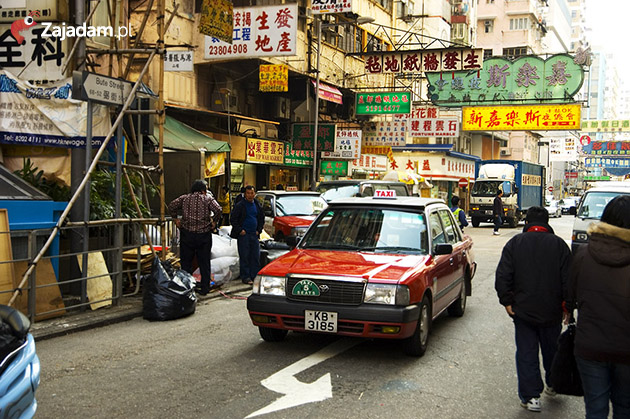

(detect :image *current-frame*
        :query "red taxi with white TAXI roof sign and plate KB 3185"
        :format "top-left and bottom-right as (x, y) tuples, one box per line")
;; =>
(247, 197), (476, 356)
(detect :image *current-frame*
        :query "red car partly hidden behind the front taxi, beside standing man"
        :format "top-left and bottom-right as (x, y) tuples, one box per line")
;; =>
(256, 191), (327, 241)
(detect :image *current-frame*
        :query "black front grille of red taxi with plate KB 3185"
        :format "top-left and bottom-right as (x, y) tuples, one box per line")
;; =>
(287, 277), (365, 305)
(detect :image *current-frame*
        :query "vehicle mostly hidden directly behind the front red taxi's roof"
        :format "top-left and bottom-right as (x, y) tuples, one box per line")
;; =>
(317, 179), (411, 202)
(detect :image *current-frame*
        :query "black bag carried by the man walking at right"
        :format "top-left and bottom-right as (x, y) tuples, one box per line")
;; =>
(549, 323), (584, 396)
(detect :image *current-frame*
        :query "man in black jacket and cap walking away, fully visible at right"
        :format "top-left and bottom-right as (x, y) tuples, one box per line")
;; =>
(495, 207), (571, 412)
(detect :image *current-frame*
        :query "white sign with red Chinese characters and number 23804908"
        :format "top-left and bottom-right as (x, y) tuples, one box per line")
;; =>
(204, 3), (298, 59)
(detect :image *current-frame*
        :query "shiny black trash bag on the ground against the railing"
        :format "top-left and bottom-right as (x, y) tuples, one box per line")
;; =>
(142, 258), (197, 320)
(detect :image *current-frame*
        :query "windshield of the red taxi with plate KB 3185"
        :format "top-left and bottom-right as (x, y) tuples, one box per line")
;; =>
(300, 207), (429, 254)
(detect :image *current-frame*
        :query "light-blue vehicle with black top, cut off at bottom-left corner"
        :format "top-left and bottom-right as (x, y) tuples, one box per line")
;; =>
(0, 305), (40, 418)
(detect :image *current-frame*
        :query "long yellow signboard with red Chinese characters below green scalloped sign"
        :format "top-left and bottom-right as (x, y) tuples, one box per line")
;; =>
(462, 104), (582, 131)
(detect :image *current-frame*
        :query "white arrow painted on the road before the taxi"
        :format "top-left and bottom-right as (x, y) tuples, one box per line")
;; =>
(247, 339), (360, 418)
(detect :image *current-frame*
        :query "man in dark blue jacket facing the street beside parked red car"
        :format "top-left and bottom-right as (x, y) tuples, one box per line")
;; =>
(230, 185), (265, 285)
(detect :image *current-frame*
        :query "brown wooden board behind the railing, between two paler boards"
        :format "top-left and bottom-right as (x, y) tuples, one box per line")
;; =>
(13, 259), (66, 321)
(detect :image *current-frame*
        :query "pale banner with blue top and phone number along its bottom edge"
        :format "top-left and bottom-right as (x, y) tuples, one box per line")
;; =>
(0, 70), (112, 148)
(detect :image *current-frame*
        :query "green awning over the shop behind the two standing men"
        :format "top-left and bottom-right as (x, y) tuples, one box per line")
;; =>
(151, 115), (230, 153)
